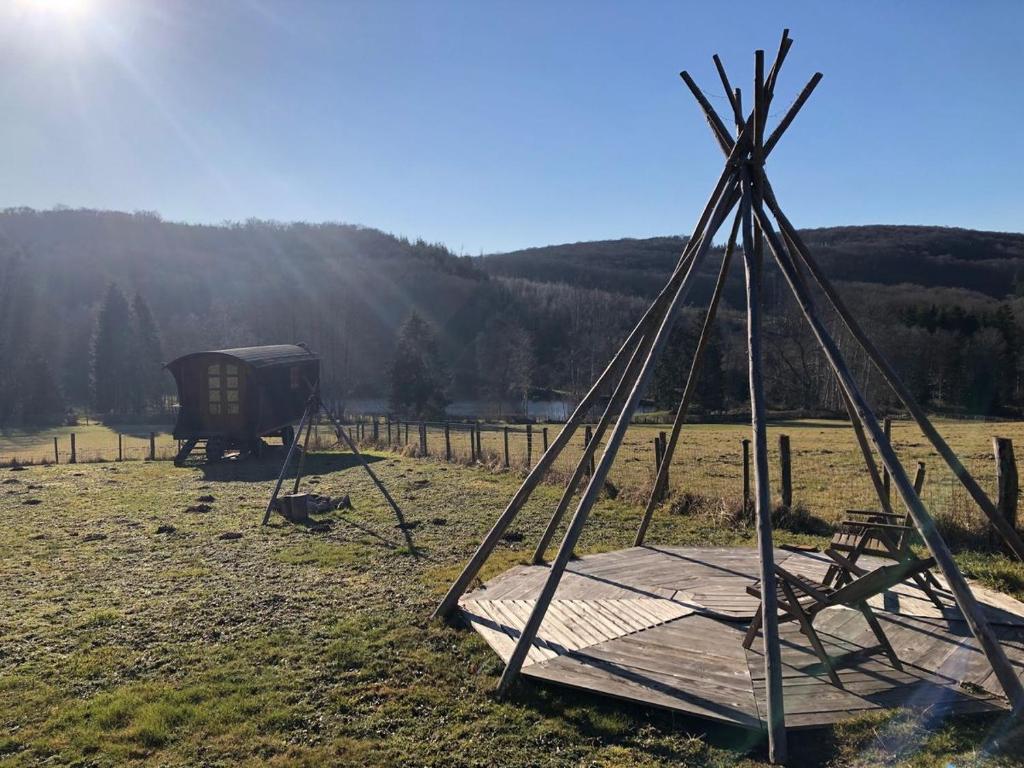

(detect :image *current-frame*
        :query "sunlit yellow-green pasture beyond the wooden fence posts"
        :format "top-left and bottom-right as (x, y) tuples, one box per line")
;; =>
(0, 419), (1024, 528)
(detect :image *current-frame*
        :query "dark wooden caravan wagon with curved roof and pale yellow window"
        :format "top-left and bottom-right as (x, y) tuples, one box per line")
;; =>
(166, 344), (319, 464)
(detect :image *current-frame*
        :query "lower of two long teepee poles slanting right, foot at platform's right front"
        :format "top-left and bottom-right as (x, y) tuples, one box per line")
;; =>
(754, 177), (1024, 710)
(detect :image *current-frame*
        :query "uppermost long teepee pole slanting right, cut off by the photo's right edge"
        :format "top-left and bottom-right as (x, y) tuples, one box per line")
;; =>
(764, 180), (1024, 560)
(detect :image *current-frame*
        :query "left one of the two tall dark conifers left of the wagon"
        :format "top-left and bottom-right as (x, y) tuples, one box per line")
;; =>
(91, 283), (134, 414)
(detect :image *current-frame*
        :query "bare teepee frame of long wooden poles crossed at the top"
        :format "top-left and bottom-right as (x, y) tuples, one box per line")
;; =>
(434, 30), (1024, 762)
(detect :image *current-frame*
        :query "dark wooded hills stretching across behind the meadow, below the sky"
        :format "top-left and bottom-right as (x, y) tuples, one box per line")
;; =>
(0, 209), (1024, 426)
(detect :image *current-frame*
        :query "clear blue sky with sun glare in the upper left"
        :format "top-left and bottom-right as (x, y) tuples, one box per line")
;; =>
(0, 0), (1024, 254)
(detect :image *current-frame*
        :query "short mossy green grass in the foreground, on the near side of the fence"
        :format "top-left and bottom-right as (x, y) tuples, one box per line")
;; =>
(0, 448), (1024, 766)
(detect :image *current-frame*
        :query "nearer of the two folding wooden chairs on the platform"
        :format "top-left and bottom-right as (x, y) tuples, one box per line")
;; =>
(743, 557), (935, 688)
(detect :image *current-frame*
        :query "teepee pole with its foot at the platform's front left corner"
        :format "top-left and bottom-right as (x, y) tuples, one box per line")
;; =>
(498, 159), (735, 696)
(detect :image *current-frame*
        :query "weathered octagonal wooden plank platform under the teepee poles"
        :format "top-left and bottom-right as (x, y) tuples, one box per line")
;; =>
(460, 547), (1024, 729)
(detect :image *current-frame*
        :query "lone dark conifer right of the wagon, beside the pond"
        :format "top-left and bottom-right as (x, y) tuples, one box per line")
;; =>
(388, 311), (447, 417)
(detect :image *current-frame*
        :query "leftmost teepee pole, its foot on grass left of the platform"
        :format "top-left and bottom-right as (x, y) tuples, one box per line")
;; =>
(432, 156), (736, 618)
